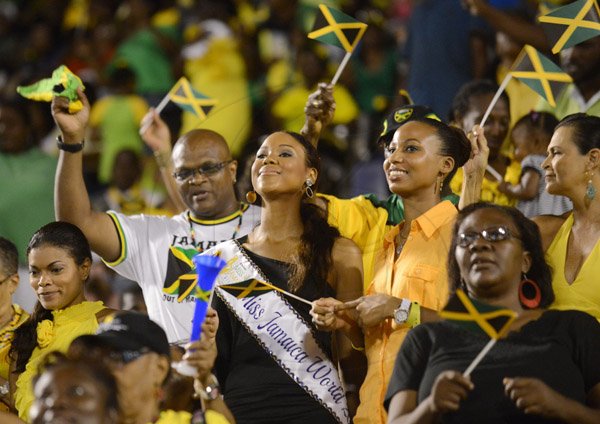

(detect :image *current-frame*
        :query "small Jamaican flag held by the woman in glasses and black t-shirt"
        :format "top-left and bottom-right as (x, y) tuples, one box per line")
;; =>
(439, 289), (517, 340)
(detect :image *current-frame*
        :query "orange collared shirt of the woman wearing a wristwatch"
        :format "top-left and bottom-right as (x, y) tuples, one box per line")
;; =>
(354, 201), (458, 424)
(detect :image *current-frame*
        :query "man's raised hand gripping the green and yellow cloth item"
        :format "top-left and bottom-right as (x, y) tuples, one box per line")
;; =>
(50, 87), (90, 143)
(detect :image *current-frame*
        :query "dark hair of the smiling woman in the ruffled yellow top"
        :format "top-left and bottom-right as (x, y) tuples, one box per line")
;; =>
(9, 221), (92, 373)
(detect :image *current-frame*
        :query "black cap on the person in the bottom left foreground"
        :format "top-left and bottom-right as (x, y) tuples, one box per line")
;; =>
(78, 312), (170, 356)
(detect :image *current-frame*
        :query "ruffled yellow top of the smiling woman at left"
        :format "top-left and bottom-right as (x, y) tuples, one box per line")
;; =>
(15, 302), (104, 421)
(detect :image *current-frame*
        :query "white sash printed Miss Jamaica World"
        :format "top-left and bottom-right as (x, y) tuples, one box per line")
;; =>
(203, 240), (350, 424)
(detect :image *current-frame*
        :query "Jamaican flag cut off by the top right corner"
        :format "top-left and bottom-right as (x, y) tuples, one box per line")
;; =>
(538, 0), (600, 54)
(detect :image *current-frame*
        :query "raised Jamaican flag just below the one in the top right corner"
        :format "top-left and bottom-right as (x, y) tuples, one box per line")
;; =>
(510, 45), (573, 107)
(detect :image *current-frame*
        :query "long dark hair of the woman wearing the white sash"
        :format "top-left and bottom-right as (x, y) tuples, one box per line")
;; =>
(286, 132), (340, 295)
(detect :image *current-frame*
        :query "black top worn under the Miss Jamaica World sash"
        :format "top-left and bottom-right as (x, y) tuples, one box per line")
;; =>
(214, 245), (336, 424)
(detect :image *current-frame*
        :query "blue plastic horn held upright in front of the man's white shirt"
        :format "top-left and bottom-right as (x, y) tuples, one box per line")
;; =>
(190, 255), (226, 342)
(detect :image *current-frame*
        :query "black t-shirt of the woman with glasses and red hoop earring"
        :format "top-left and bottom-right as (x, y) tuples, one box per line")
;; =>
(385, 311), (600, 423)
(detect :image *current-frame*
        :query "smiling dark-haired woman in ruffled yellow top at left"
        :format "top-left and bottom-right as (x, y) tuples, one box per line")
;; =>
(9, 222), (110, 421)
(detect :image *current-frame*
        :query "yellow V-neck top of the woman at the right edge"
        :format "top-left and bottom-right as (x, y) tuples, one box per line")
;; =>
(546, 214), (600, 320)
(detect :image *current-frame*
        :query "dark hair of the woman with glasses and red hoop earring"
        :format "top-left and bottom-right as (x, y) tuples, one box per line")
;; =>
(448, 202), (554, 309)
